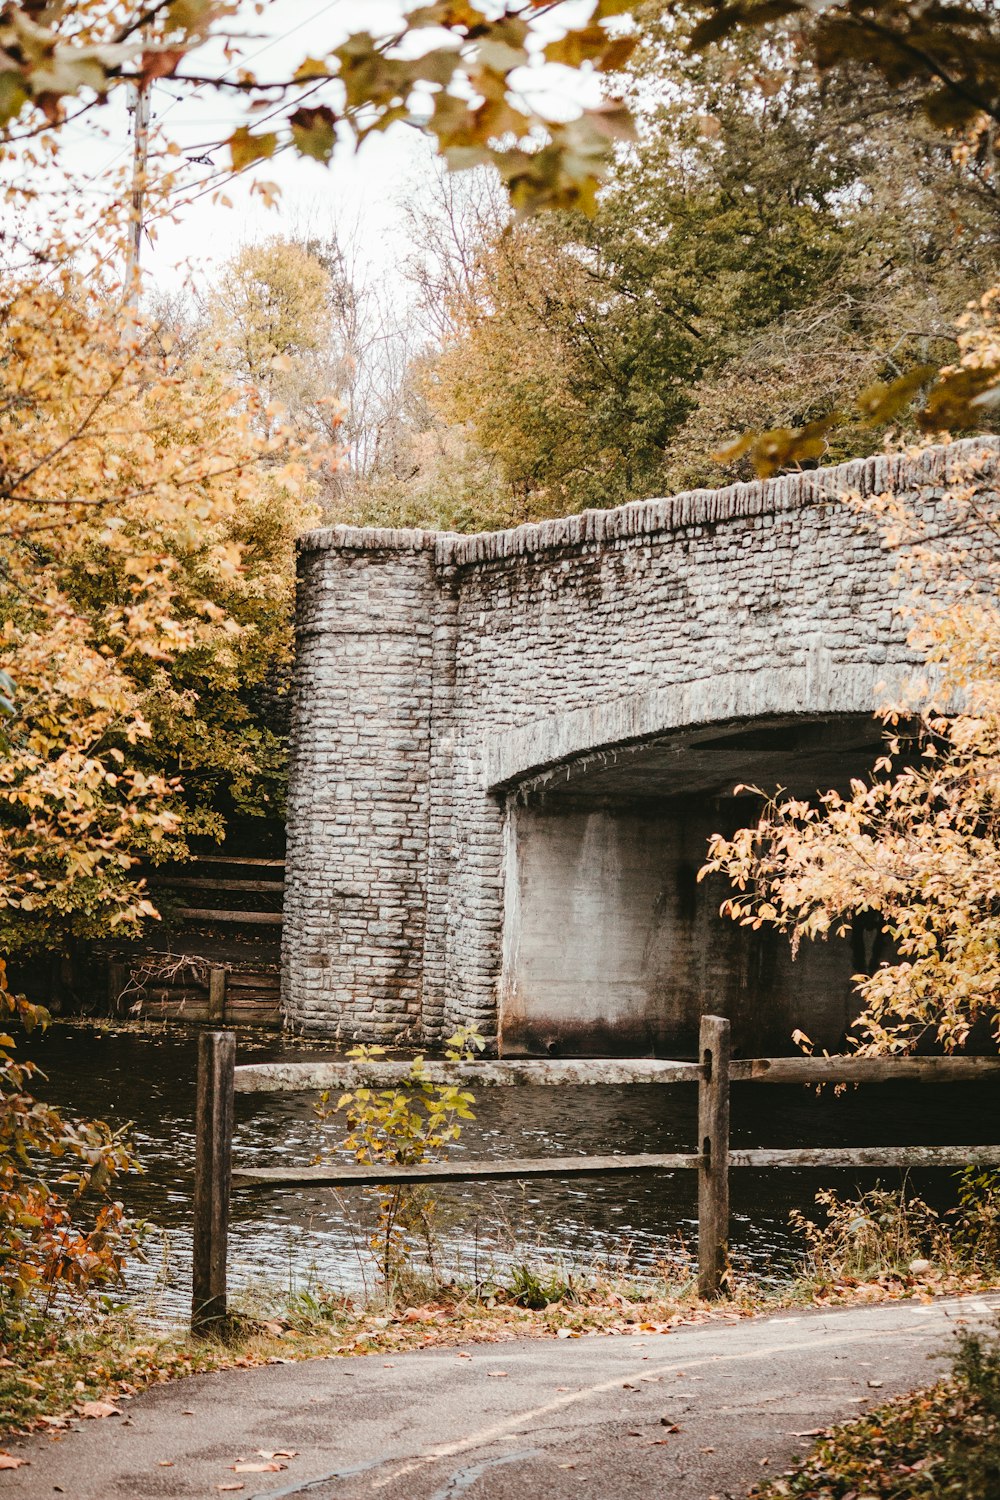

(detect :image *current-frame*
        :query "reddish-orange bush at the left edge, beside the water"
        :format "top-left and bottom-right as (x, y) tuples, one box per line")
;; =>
(0, 963), (138, 1337)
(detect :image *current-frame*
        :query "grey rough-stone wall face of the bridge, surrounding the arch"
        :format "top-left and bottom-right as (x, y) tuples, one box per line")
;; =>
(283, 440), (997, 1046)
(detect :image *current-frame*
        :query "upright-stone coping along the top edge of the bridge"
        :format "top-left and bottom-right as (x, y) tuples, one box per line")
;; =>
(298, 437), (1000, 567)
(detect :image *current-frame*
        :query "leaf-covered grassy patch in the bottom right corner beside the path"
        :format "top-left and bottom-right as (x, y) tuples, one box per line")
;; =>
(751, 1319), (1000, 1500)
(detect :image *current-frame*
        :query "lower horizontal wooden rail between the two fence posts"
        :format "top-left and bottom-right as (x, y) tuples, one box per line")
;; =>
(232, 1152), (702, 1188)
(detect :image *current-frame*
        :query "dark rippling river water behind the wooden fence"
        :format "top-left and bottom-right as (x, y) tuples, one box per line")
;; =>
(25, 1028), (1000, 1316)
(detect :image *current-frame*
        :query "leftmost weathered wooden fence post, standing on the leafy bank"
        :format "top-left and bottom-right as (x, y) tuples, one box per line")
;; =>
(190, 1032), (235, 1334)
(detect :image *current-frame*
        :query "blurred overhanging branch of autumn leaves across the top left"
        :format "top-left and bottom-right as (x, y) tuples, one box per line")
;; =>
(0, 0), (633, 212)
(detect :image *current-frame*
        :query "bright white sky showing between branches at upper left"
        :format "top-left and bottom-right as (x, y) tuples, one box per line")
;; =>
(64, 0), (598, 304)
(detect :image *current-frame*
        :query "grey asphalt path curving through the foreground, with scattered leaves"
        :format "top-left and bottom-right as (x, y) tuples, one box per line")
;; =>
(0, 1296), (1000, 1500)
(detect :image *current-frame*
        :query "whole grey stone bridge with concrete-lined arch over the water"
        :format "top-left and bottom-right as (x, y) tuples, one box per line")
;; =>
(283, 440), (1000, 1055)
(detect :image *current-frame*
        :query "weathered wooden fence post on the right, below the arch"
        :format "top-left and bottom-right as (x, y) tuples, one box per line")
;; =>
(699, 1016), (730, 1298)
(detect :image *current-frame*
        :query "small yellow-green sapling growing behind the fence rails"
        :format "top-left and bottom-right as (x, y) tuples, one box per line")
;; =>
(316, 1026), (486, 1299)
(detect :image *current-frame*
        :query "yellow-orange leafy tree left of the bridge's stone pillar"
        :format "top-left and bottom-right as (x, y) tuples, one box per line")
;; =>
(0, 244), (320, 951)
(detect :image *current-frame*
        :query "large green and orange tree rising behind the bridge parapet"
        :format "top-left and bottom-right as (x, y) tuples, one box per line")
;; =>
(423, 21), (1000, 516)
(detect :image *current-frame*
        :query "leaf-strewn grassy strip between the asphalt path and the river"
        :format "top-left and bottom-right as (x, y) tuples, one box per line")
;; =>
(0, 1268), (1000, 1436)
